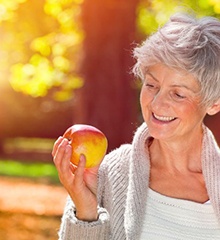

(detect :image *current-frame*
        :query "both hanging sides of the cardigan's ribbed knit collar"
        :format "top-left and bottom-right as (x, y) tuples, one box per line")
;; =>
(125, 123), (220, 240)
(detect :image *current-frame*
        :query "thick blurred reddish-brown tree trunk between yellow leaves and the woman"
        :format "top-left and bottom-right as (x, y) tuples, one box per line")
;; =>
(73, 0), (138, 150)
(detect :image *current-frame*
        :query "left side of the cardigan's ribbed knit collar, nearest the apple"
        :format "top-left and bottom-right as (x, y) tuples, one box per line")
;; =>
(125, 123), (150, 240)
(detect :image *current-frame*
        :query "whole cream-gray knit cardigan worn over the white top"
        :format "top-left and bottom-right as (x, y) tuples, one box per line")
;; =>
(59, 123), (220, 240)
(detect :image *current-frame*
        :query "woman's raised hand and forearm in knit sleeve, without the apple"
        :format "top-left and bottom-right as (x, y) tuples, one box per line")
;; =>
(52, 137), (109, 240)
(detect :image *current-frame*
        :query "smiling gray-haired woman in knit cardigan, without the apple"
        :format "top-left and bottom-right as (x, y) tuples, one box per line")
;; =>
(52, 14), (220, 240)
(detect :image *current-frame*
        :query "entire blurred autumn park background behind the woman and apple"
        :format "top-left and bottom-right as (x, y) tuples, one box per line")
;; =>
(0, 0), (220, 240)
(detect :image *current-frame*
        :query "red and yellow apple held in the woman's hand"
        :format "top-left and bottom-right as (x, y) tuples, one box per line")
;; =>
(63, 124), (108, 168)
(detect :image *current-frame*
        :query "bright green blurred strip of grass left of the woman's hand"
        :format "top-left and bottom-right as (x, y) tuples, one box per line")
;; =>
(0, 159), (59, 183)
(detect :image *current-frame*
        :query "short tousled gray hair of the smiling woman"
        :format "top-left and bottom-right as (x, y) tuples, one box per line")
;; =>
(133, 13), (220, 105)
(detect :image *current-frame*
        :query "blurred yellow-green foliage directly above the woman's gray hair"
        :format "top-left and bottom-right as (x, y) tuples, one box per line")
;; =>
(137, 0), (220, 35)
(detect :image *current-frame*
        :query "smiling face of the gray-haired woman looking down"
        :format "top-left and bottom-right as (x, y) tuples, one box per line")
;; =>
(140, 64), (206, 140)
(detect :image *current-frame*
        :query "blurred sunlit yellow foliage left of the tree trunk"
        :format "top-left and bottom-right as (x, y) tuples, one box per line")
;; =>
(0, 0), (83, 101)
